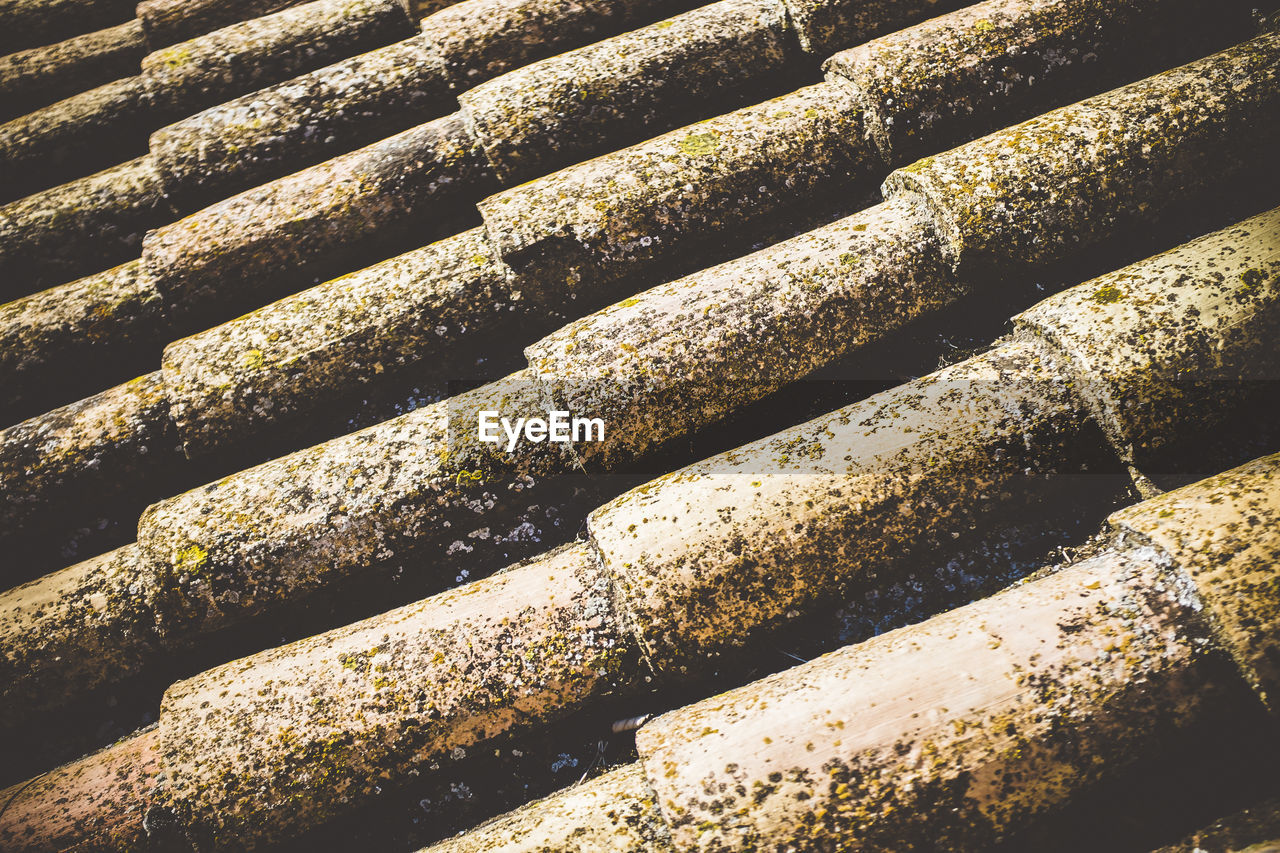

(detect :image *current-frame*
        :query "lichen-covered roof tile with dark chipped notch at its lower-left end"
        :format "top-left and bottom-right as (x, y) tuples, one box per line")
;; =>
(480, 83), (877, 297)
